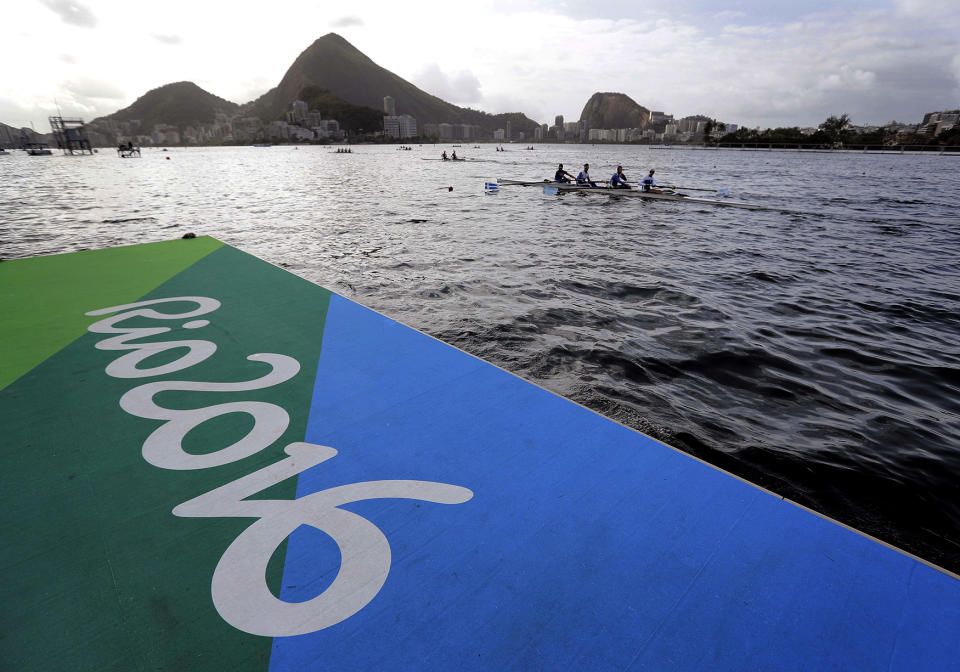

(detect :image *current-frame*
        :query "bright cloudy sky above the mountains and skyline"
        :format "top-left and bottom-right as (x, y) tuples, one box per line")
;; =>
(0, 0), (960, 132)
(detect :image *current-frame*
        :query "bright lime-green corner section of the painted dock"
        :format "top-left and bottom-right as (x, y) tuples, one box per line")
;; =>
(0, 236), (223, 390)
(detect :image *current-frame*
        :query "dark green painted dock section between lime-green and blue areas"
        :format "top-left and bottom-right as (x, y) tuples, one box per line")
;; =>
(0, 241), (330, 672)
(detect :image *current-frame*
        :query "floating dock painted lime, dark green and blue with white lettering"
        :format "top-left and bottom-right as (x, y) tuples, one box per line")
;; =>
(0, 238), (960, 672)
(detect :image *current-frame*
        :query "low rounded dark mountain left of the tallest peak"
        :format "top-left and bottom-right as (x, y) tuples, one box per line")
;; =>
(91, 82), (240, 129)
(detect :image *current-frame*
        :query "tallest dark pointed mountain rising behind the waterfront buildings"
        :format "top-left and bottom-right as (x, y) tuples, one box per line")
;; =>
(250, 33), (537, 133)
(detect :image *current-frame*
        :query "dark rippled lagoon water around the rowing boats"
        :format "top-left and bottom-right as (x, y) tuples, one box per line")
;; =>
(0, 144), (960, 571)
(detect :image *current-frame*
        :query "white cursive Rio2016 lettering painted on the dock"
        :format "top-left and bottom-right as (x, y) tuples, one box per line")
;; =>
(87, 296), (473, 637)
